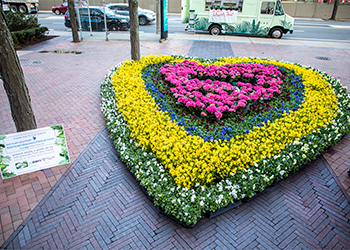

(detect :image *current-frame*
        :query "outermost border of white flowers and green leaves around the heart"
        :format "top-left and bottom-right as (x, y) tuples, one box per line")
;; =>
(101, 56), (350, 225)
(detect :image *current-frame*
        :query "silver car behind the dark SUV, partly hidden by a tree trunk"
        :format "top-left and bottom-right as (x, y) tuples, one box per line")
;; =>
(106, 3), (156, 25)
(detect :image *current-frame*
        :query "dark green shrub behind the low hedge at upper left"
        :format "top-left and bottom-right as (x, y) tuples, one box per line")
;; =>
(5, 12), (40, 32)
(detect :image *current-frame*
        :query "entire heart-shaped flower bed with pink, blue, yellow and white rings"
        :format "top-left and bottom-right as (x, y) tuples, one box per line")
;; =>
(101, 56), (350, 227)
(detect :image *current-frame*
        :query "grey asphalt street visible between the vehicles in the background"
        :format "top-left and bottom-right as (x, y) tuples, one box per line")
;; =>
(38, 11), (350, 42)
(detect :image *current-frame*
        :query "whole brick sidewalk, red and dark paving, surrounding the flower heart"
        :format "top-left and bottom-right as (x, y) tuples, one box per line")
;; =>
(0, 32), (350, 249)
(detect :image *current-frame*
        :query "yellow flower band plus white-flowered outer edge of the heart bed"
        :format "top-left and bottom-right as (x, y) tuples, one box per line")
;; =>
(101, 55), (350, 224)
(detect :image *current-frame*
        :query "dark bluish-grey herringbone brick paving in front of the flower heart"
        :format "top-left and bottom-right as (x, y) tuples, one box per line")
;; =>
(3, 128), (350, 249)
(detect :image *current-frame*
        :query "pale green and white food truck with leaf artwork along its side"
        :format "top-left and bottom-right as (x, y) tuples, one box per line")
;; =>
(181, 0), (294, 38)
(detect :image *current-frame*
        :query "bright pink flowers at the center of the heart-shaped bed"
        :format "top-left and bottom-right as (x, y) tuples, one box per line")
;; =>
(160, 60), (282, 119)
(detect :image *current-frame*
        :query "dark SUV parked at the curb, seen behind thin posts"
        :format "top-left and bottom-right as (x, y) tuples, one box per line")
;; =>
(64, 6), (130, 31)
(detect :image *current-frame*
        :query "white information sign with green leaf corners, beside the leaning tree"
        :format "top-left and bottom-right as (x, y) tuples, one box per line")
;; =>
(0, 125), (70, 179)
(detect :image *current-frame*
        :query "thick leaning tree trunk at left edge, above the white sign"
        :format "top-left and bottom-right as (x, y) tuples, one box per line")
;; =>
(0, 8), (36, 132)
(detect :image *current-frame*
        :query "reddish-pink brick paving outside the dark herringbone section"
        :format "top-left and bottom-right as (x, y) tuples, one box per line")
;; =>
(0, 33), (350, 246)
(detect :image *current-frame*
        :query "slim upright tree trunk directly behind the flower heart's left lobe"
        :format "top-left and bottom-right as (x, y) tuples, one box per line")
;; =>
(129, 0), (140, 61)
